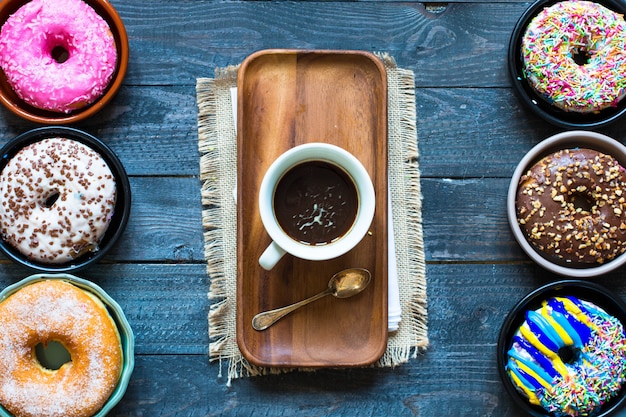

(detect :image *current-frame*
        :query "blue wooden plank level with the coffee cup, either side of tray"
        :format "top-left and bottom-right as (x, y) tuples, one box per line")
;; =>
(2, 177), (576, 264)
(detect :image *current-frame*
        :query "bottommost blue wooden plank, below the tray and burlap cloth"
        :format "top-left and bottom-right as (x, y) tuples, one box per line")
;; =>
(109, 349), (524, 417)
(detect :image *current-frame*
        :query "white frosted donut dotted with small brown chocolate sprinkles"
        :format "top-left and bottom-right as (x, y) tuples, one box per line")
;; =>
(0, 138), (116, 264)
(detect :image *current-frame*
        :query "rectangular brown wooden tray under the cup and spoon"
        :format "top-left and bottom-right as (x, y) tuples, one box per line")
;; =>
(237, 50), (387, 367)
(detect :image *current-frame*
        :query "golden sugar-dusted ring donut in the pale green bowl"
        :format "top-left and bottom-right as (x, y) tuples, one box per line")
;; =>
(0, 279), (123, 417)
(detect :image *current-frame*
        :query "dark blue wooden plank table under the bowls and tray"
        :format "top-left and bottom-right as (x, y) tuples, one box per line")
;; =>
(0, 0), (626, 417)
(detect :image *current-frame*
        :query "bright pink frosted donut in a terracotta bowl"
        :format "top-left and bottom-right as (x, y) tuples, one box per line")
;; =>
(0, 0), (117, 113)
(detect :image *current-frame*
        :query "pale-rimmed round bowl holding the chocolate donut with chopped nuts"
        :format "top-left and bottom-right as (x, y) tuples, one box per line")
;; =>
(507, 130), (626, 278)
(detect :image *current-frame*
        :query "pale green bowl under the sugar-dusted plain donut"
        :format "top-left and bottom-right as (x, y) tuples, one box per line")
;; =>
(0, 274), (135, 417)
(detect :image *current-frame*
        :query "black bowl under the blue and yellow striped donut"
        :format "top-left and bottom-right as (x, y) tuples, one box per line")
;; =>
(497, 280), (626, 417)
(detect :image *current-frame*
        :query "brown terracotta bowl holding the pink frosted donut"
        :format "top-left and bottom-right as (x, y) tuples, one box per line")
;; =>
(0, 0), (129, 125)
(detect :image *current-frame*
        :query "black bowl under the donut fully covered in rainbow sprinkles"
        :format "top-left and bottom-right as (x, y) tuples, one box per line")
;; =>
(508, 0), (626, 129)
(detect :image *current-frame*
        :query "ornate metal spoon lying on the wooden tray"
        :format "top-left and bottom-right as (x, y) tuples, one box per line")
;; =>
(252, 268), (372, 330)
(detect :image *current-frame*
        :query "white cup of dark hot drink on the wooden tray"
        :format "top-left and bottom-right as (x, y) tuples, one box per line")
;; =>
(259, 142), (375, 271)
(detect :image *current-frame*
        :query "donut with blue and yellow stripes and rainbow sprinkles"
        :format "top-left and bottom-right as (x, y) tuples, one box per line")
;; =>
(506, 296), (626, 417)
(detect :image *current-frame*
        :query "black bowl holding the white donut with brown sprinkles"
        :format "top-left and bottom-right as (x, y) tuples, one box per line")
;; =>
(0, 126), (131, 272)
